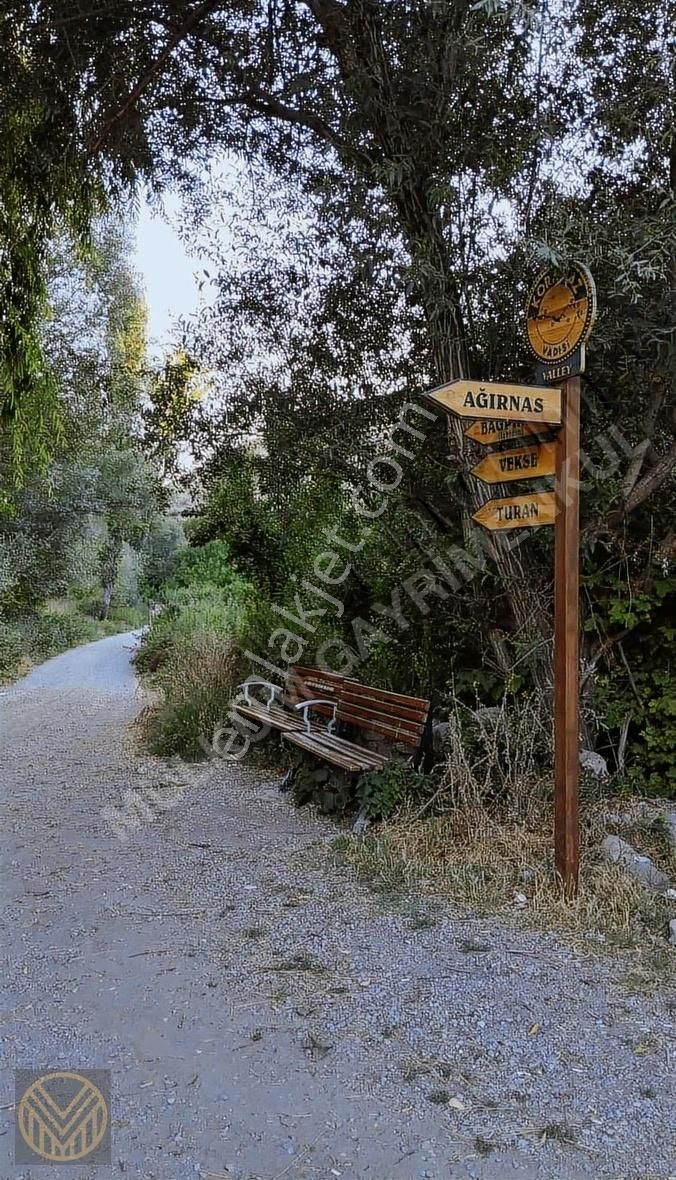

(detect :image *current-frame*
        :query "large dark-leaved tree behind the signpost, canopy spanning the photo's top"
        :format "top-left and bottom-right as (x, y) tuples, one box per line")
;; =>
(0, 0), (676, 769)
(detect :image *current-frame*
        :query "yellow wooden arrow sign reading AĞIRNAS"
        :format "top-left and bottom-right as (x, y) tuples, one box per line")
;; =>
(427, 380), (562, 422)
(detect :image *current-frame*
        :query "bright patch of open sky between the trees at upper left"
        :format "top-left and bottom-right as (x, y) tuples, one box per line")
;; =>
(134, 196), (201, 355)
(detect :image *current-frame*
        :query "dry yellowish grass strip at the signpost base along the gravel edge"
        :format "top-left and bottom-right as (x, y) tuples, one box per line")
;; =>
(334, 774), (676, 977)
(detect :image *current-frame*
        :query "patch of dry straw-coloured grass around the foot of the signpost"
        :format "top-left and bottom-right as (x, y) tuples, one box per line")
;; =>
(337, 791), (676, 990)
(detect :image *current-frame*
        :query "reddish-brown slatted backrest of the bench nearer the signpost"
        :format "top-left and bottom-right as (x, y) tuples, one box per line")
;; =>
(336, 680), (429, 746)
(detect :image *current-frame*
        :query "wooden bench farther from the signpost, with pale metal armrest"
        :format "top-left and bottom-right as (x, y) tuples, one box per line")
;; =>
(236, 666), (344, 734)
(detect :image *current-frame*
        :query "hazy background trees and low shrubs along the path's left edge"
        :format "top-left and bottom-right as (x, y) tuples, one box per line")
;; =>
(0, 218), (184, 683)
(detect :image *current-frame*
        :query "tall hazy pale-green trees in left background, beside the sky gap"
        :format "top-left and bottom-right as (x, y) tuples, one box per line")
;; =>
(0, 221), (164, 618)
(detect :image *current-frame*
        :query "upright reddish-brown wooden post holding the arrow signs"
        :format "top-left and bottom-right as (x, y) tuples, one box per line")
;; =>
(554, 376), (580, 896)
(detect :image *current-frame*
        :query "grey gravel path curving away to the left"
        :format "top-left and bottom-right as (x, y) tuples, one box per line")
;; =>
(0, 636), (676, 1180)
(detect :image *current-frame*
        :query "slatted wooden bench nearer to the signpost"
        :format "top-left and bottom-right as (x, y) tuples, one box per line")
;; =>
(283, 680), (432, 774)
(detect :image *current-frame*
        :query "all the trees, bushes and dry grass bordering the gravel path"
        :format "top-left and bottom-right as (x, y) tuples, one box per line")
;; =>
(0, 0), (676, 938)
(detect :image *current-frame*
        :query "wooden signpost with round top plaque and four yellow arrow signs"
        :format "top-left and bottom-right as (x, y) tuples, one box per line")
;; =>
(427, 264), (596, 896)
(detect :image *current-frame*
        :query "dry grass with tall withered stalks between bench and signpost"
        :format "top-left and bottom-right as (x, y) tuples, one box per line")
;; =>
(339, 701), (676, 990)
